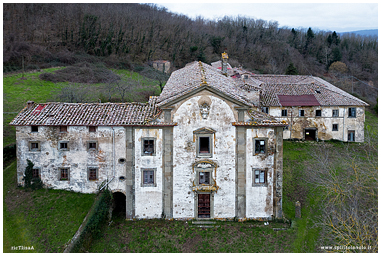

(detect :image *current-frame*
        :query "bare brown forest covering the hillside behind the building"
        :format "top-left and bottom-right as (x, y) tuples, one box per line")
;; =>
(3, 3), (378, 98)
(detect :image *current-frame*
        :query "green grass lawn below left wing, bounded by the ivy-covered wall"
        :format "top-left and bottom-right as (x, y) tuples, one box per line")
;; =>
(3, 162), (95, 252)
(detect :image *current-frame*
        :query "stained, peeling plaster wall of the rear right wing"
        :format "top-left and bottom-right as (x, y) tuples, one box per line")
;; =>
(269, 106), (365, 142)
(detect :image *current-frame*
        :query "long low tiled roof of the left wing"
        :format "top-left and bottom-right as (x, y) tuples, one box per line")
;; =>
(10, 97), (174, 126)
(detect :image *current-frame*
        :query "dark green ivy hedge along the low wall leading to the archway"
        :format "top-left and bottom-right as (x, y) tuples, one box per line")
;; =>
(71, 189), (112, 252)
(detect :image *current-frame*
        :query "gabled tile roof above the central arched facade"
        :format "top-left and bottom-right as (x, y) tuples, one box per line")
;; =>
(158, 62), (253, 106)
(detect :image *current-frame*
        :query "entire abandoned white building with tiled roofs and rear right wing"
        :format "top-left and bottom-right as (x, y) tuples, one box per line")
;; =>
(11, 55), (366, 219)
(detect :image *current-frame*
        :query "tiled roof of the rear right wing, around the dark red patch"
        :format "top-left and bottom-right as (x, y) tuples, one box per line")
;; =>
(252, 75), (368, 106)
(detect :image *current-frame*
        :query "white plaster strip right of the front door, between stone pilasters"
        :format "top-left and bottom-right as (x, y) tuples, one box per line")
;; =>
(246, 128), (276, 218)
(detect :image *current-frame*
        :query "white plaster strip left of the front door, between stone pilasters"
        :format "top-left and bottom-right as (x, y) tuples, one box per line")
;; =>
(135, 128), (163, 218)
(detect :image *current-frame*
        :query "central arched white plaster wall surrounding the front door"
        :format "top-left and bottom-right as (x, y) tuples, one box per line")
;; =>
(172, 91), (235, 218)
